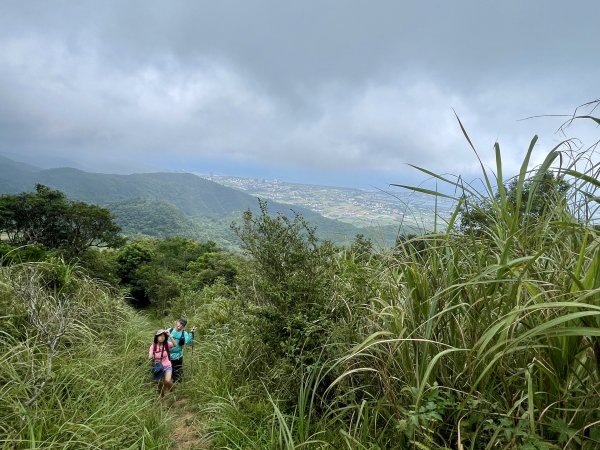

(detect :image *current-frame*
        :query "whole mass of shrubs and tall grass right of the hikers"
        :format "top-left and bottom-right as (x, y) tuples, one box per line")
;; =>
(180, 103), (600, 450)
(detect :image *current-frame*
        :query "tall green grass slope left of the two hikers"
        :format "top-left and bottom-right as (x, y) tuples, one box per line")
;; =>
(0, 261), (170, 449)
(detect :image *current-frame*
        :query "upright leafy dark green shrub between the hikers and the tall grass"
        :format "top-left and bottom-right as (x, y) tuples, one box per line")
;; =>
(235, 201), (335, 378)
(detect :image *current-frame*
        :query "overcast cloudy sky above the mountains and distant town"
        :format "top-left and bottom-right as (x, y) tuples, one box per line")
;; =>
(0, 0), (600, 187)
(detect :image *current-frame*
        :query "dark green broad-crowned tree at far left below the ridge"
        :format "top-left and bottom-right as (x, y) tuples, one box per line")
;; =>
(0, 184), (123, 256)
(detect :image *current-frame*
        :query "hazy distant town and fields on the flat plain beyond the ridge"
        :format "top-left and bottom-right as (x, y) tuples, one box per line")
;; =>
(201, 175), (452, 230)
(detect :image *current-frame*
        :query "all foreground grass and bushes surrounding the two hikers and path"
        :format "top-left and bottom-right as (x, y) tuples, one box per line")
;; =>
(0, 103), (600, 450)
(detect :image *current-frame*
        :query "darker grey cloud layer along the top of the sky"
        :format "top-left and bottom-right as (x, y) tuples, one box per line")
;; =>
(3, 0), (599, 90)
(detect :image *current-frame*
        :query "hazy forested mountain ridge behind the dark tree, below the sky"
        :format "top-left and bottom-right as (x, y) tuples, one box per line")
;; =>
(0, 156), (398, 245)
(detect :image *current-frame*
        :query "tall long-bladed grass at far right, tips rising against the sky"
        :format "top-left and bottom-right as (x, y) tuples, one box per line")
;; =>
(324, 111), (600, 448)
